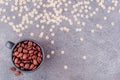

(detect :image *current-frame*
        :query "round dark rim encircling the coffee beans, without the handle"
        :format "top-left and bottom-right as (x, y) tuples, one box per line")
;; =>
(11, 39), (45, 72)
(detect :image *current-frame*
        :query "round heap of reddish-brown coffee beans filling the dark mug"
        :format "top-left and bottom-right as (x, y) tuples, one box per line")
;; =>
(12, 40), (43, 71)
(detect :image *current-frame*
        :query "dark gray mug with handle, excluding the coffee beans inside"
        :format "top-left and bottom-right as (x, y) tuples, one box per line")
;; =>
(5, 40), (44, 72)
